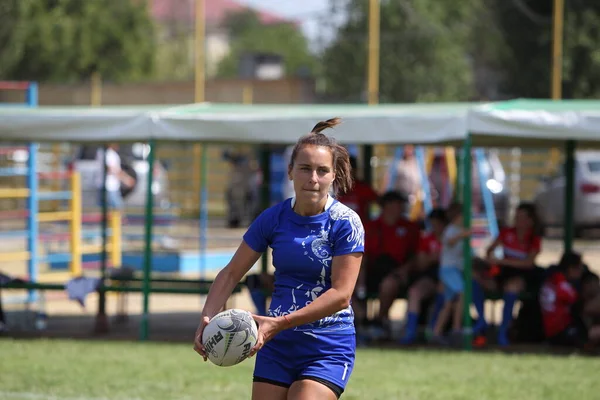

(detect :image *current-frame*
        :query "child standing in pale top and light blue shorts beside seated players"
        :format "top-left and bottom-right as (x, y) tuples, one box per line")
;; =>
(433, 203), (471, 343)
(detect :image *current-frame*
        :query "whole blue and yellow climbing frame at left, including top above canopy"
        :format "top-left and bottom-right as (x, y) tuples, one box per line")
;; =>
(0, 82), (121, 303)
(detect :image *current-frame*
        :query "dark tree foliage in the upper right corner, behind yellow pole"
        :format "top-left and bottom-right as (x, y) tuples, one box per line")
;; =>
(486, 0), (600, 98)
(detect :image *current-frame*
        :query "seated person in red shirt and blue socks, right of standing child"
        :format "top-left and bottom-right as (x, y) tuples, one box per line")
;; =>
(473, 203), (542, 346)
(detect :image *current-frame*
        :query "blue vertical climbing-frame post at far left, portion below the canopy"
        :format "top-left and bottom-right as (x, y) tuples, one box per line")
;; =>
(27, 143), (39, 302)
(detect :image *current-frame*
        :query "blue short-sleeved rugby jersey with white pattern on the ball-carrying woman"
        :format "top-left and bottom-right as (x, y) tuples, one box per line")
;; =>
(244, 196), (365, 335)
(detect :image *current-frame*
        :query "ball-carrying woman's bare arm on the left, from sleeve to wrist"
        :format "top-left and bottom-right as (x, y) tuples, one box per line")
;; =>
(202, 241), (261, 319)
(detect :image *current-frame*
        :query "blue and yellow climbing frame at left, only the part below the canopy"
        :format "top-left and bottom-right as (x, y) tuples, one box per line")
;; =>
(0, 144), (122, 282)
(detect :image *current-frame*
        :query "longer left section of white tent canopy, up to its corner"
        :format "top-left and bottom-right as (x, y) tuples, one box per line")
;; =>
(0, 103), (471, 144)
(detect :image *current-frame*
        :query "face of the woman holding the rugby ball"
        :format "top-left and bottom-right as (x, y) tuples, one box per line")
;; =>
(288, 145), (335, 204)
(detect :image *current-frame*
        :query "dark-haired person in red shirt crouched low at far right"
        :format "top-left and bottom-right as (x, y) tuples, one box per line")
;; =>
(539, 252), (587, 346)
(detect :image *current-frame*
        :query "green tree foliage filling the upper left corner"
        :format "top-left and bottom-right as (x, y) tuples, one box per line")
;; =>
(0, 0), (155, 82)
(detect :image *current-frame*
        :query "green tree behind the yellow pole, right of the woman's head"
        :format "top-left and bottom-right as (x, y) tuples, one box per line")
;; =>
(323, 0), (474, 102)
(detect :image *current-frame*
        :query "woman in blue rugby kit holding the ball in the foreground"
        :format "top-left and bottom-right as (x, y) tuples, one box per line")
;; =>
(194, 118), (364, 400)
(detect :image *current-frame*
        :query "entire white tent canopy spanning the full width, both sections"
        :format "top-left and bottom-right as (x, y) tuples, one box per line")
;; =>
(0, 100), (600, 147)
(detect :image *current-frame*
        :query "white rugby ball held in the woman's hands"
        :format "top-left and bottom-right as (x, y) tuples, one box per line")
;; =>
(202, 308), (258, 367)
